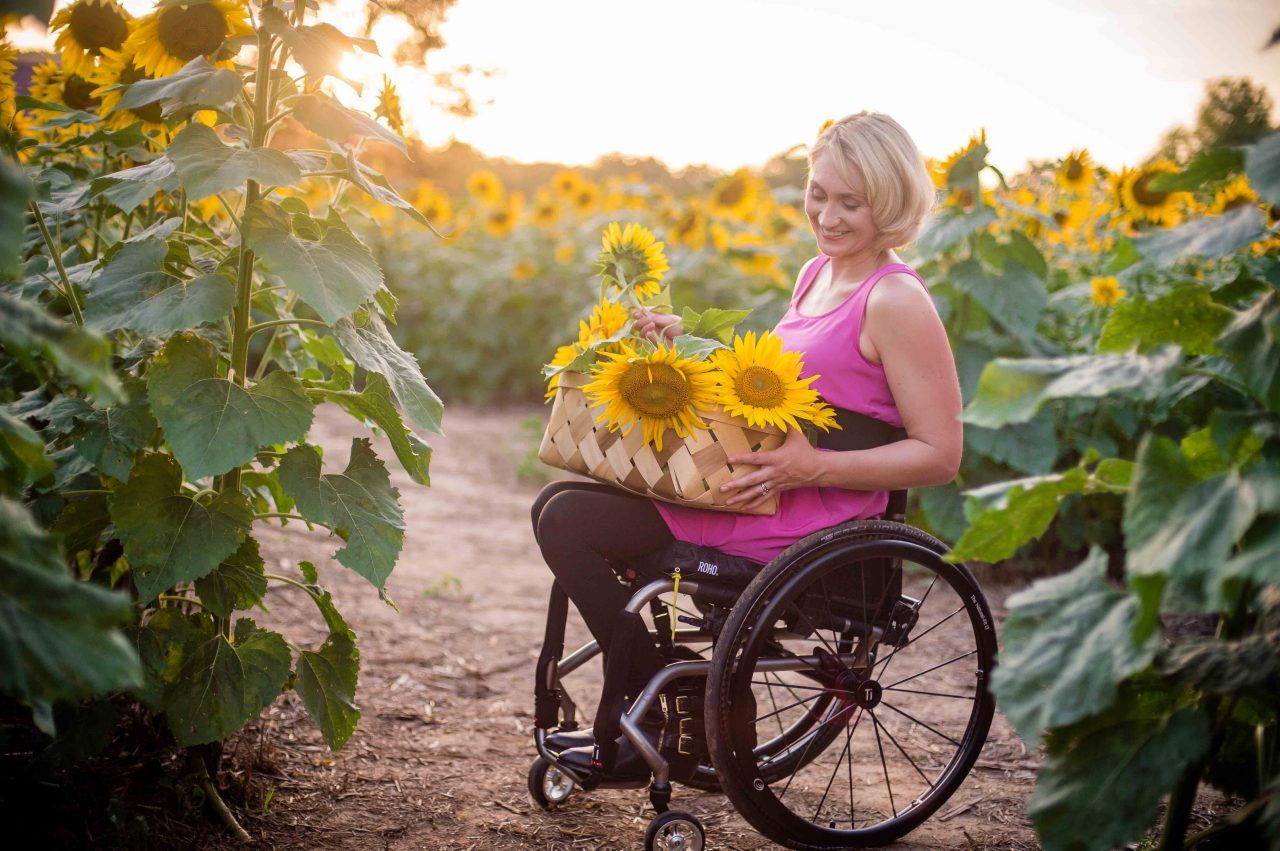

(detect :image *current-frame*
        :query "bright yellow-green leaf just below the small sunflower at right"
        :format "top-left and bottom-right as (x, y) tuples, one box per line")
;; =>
(1098, 284), (1235, 356)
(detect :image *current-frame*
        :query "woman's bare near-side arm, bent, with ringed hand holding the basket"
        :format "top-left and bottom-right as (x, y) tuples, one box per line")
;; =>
(723, 276), (964, 507)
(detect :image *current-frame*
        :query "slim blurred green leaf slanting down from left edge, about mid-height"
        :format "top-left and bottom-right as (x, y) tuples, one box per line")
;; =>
(0, 292), (124, 404)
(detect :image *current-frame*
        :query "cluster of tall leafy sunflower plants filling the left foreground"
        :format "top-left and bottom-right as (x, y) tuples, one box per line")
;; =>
(0, 0), (443, 834)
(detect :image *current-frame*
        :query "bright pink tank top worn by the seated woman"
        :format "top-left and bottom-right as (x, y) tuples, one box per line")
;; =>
(654, 255), (924, 562)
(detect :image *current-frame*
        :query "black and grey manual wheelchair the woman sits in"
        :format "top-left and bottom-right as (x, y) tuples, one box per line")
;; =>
(529, 412), (996, 851)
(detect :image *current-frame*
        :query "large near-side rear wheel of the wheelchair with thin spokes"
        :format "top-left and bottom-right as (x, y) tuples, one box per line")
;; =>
(707, 521), (996, 850)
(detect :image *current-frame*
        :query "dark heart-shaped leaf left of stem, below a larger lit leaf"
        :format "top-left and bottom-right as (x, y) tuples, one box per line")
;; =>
(111, 453), (253, 604)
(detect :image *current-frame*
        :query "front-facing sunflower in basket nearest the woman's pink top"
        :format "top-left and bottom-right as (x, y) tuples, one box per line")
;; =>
(712, 331), (835, 431)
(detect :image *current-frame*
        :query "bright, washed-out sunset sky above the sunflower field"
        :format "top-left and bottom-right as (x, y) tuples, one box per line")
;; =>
(12, 0), (1280, 171)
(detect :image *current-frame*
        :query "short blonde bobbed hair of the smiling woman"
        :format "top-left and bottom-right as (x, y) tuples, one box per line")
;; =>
(809, 110), (937, 250)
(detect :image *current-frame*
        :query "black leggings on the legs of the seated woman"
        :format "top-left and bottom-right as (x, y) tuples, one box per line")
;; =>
(530, 481), (673, 696)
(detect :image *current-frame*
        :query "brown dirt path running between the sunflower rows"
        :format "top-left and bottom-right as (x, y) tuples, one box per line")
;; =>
(217, 407), (1036, 851)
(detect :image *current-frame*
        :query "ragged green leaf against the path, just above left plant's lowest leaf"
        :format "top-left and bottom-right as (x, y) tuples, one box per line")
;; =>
(280, 438), (404, 590)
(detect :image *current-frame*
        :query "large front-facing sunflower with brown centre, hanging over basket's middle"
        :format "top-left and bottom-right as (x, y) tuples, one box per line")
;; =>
(582, 343), (716, 452)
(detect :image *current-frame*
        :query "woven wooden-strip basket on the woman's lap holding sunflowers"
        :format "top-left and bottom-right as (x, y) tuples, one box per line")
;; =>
(538, 372), (785, 514)
